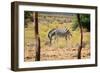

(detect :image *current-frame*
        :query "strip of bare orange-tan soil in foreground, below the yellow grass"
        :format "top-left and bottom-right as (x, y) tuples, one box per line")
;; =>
(24, 47), (90, 62)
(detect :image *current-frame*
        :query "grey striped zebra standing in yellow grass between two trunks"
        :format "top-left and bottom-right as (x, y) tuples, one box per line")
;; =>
(48, 28), (72, 44)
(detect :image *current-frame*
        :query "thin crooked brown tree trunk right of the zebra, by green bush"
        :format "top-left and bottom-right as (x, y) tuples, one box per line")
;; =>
(77, 14), (83, 59)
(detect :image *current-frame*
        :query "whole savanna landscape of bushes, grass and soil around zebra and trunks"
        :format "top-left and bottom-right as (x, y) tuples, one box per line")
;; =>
(24, 11), (90, 61)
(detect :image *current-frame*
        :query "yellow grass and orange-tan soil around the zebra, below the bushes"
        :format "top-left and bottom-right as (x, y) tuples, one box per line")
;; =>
(24, 22), (90, 62)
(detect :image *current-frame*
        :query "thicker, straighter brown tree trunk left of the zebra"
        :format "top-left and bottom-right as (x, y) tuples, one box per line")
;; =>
(35, 12), (40, 61)
